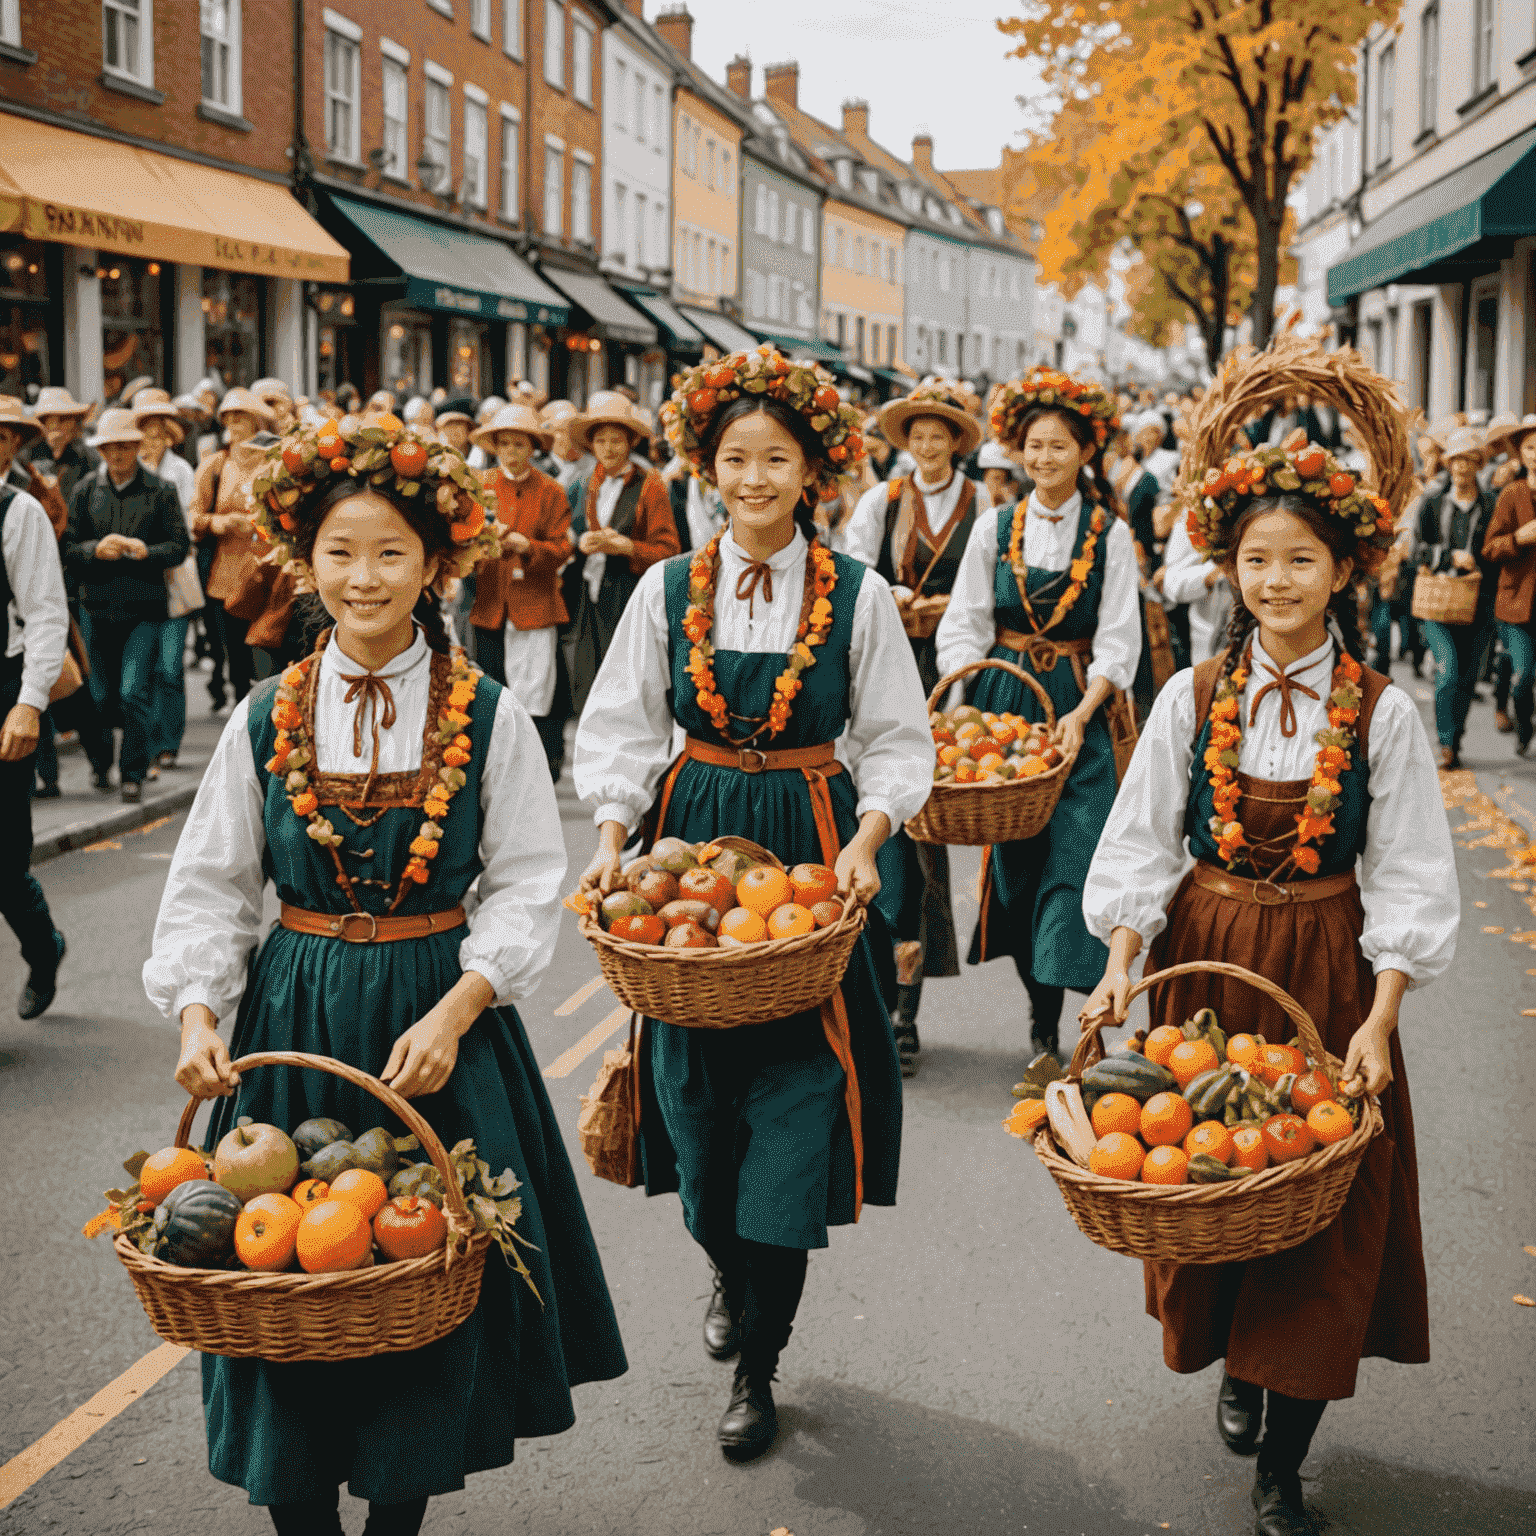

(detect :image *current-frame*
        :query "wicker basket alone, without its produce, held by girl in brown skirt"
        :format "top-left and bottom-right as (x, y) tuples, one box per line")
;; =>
(1035, 960), (1382, 1264)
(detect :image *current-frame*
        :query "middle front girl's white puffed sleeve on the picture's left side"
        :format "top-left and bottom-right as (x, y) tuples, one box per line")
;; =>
(571, 565), (673, 831)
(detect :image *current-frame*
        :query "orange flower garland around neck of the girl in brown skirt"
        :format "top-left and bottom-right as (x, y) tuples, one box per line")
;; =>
(1206, 645), (1361, 880)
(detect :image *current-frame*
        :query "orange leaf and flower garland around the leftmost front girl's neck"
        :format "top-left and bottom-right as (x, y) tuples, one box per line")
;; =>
(267, 631), (482, 912)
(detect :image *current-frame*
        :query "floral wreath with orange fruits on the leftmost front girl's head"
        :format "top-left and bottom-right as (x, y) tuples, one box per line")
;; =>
(250, 415), (499, 576)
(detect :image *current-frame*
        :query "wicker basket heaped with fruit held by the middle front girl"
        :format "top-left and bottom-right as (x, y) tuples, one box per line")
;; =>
(571, 837), (865, 1029)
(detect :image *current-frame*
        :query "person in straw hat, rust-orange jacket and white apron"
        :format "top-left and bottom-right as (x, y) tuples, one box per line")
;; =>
(470, 406), (571, 779)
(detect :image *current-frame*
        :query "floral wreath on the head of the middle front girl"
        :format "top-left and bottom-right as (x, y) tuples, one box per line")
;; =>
(662, 341), (865, 501)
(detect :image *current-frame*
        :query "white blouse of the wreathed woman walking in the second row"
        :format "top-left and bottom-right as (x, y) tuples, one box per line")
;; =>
(934, 492), (1141, 688)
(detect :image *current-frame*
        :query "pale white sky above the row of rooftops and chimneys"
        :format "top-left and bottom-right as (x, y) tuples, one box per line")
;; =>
(678, 0), (1034, 170)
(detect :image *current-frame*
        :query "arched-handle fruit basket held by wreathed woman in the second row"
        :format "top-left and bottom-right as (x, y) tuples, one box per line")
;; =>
(906, 659), (1074, 846)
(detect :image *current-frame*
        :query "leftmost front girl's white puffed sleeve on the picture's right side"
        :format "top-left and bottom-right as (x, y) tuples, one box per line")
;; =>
(459, 688), (565, 1006)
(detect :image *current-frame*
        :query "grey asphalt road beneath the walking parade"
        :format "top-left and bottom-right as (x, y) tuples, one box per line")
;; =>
(0, 663), (1536, 1536)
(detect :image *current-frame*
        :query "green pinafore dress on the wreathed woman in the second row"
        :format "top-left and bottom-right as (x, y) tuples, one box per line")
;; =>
(968, 499), (1117, 992)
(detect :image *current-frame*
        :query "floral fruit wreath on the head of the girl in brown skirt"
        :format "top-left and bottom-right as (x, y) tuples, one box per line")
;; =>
(1186, 429), (1393, 571)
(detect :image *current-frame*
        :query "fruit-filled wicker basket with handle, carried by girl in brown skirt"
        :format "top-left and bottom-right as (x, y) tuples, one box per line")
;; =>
(1026, 960), (1382, 1264)
